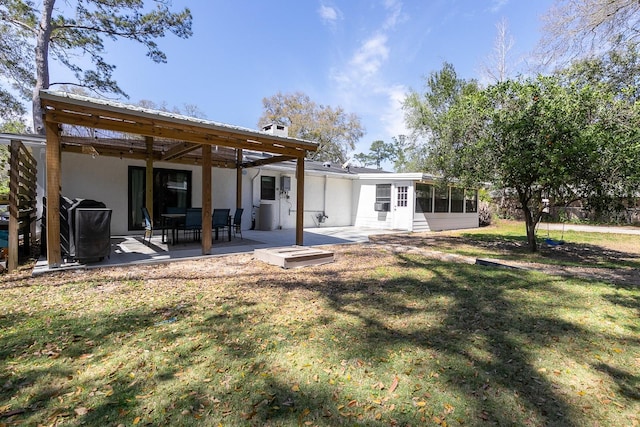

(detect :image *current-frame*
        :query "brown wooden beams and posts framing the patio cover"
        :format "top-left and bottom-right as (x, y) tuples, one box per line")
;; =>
(40, 90), (318, 267)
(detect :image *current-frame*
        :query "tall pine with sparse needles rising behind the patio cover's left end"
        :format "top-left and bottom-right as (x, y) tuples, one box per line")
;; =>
(0, 0), (192, 133)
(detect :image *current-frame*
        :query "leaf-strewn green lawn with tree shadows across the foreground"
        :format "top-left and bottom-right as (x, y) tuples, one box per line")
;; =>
(0, 224), (640, 426)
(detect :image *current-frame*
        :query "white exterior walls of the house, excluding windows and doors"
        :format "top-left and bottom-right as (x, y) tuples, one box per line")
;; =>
(55, 154), (478, 235)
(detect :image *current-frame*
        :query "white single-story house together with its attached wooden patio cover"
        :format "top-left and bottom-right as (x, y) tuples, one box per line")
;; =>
(0, 92), (478, 260)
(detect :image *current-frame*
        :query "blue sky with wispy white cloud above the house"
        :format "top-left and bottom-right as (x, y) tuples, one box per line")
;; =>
(52, 0), (552, 157)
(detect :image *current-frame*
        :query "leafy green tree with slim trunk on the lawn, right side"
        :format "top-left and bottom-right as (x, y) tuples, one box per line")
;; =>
(405, 64), (640, 251)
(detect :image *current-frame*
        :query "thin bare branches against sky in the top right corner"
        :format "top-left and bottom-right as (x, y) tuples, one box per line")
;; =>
(540, 0), (640, 64)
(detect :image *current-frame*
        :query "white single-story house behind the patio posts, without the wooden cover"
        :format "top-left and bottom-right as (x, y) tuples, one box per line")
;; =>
(0, 134), (478, 235)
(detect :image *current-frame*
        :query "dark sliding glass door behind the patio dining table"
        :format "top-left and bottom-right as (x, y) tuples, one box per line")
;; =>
(127, 166), (191, 230)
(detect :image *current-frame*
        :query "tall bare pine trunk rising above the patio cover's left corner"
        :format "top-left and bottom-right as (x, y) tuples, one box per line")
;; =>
(32, 0), (56, 135)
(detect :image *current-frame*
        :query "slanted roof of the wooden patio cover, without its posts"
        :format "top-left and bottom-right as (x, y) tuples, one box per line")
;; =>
(40, 90), (318, 167)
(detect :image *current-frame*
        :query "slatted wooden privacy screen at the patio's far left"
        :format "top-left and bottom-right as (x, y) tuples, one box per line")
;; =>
(7, 141), (37, 271)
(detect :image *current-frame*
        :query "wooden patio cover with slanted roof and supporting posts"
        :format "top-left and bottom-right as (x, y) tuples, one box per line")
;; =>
(40, 90), (318, 267)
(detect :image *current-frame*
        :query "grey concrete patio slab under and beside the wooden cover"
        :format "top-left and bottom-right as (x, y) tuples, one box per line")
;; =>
(33, 227), (397, 275)
